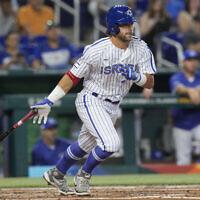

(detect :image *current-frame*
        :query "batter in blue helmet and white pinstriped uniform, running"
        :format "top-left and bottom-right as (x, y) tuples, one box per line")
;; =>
(31, 5), (156, 195)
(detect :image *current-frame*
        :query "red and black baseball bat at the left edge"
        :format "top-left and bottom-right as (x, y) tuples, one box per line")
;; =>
(0, 109), (37, 142)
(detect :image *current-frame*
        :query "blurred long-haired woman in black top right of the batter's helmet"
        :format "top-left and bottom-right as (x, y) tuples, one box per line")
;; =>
(140, 0), (172, 54)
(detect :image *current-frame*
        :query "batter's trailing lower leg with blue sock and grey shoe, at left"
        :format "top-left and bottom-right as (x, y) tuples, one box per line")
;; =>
(44, 125), (96, 195)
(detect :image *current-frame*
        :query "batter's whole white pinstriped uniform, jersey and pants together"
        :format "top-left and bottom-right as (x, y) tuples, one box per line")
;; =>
(70, 37), (156, 152)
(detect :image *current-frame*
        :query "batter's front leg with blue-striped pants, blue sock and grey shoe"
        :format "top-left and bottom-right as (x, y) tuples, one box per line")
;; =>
(74, 95), (120, 195)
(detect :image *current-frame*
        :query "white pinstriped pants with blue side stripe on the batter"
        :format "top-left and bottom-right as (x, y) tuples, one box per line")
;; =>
(75, 90), (120, 153)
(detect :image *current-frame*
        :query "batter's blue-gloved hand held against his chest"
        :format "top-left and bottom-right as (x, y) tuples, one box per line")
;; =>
(120, 65), (140, 83)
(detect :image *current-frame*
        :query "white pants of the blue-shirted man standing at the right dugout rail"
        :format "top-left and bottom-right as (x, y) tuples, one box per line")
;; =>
(173, 127), (192, 165)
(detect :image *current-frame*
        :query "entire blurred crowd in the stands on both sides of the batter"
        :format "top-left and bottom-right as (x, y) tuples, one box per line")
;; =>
(0, 0), (200, 69)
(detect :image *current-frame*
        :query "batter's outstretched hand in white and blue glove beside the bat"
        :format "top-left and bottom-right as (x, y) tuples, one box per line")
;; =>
(31, 98), (53, 124)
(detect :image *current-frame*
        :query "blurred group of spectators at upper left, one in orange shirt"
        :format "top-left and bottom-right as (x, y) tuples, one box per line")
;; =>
(0, 0), (78, 70)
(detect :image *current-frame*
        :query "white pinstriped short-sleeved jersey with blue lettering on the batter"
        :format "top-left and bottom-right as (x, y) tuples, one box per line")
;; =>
(70, 37), (156, 101)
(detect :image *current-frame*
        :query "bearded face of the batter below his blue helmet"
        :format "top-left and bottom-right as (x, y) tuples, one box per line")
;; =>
(117, 23), (134, 42)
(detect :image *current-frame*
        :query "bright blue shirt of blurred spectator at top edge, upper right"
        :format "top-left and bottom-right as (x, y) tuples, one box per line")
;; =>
(165, 0), (185, 22)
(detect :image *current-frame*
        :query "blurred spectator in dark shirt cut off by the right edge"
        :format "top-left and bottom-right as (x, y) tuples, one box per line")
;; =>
(184, 13), (200, 55)
